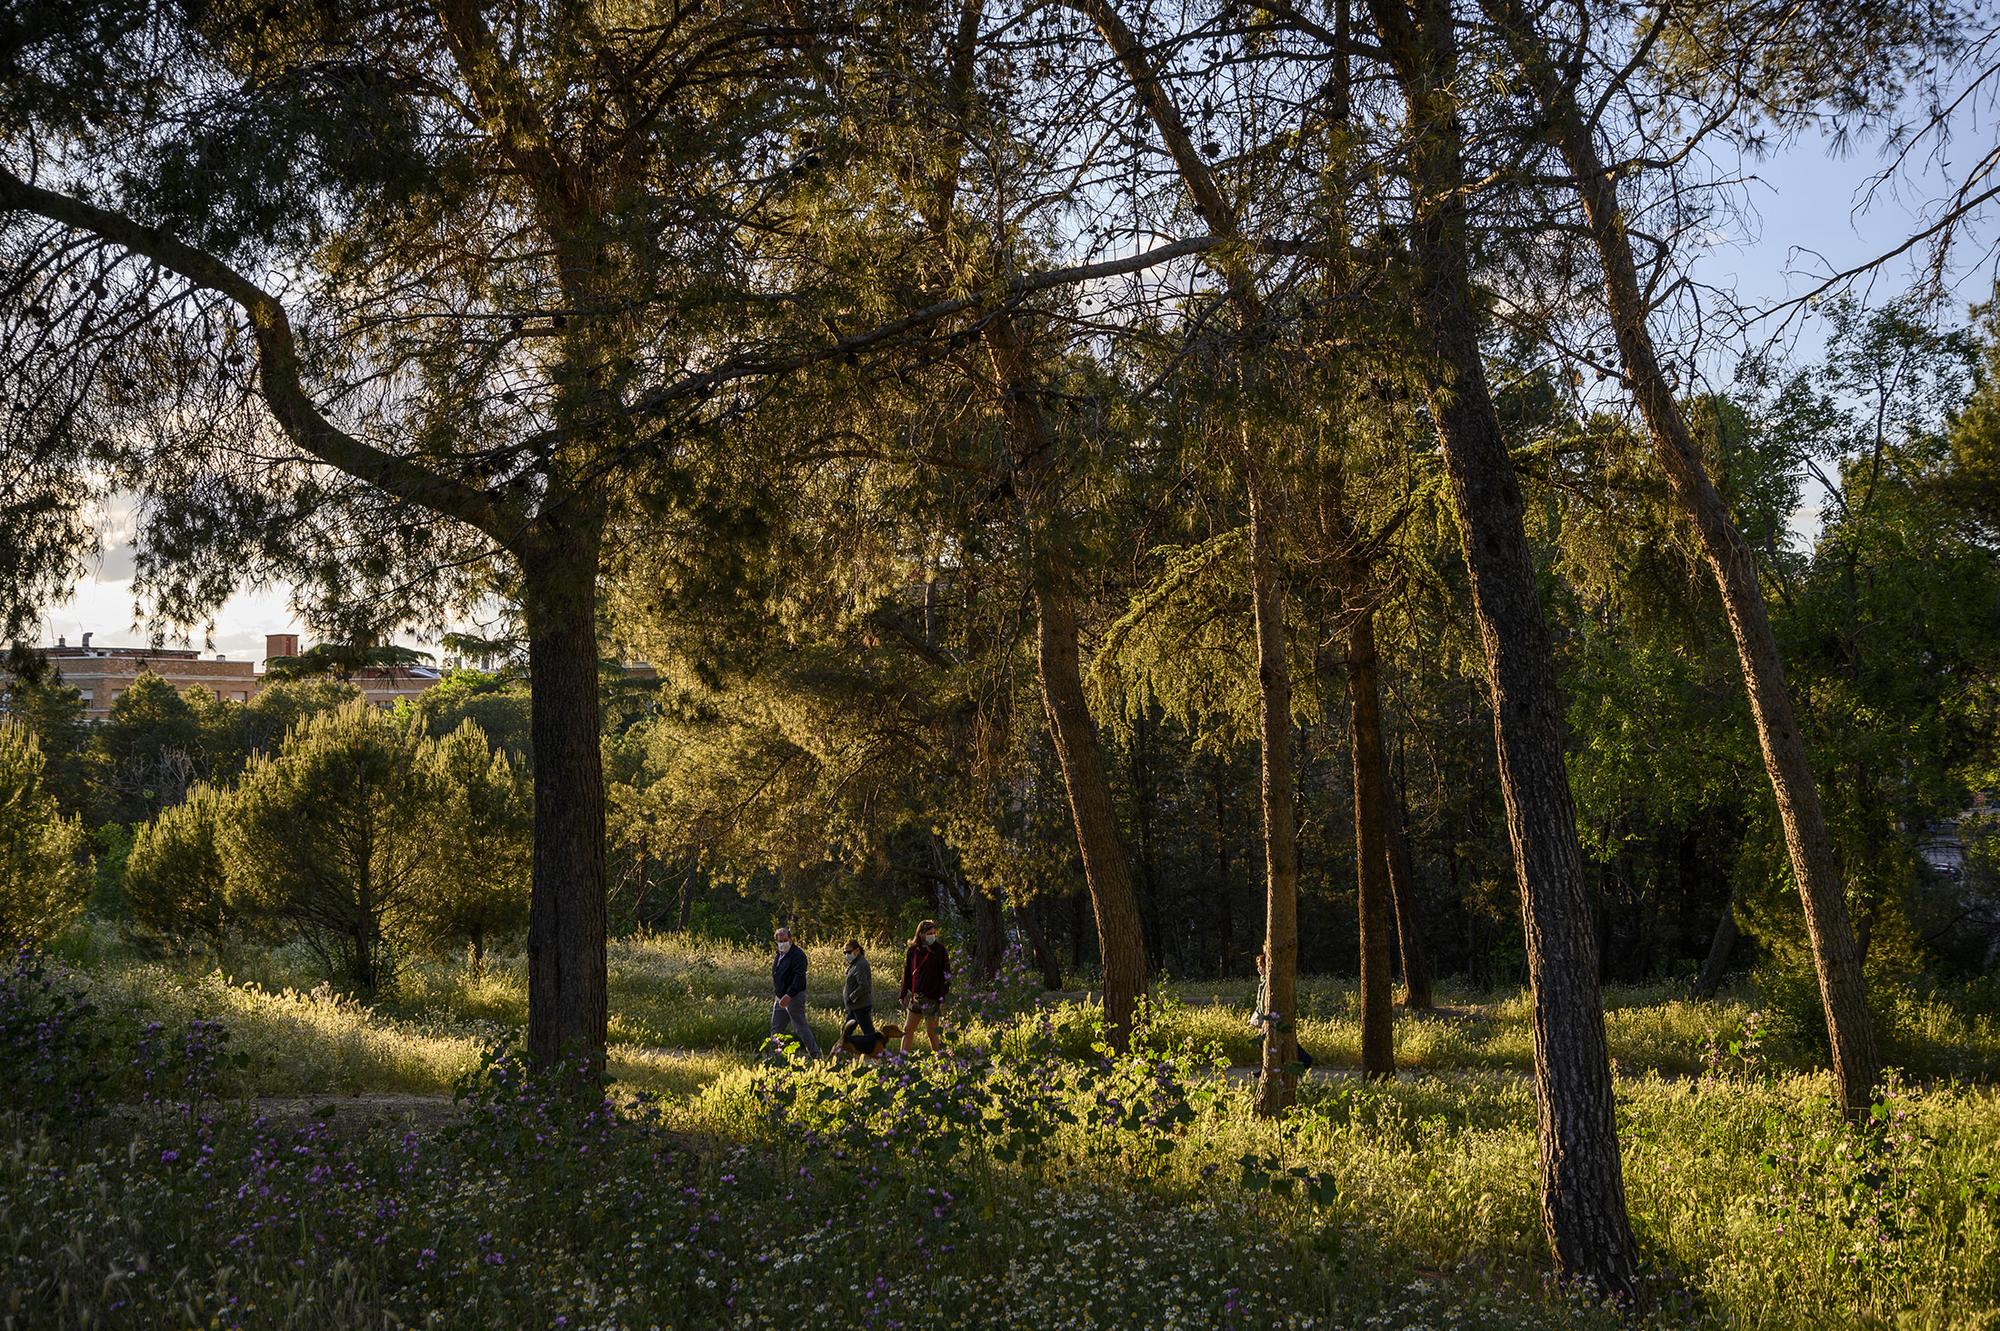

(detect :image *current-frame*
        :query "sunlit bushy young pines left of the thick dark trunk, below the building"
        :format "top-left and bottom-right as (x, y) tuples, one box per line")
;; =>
(0, 673), (532, 997)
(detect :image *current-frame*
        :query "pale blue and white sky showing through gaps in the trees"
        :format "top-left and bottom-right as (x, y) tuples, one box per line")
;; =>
(31, 78), (2000, 660)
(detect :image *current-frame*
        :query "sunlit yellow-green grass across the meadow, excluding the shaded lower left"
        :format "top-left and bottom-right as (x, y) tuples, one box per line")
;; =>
(15, 923), (2000, 1331)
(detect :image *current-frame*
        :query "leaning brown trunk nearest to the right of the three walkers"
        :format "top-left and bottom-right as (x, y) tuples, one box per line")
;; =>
(1034, 576), (1146, 1049)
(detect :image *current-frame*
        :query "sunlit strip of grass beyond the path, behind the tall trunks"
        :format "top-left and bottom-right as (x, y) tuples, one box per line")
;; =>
(66, 925), (2000, 1093)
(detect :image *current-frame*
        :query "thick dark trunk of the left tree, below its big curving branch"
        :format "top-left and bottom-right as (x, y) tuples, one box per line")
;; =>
(522, 536), (606, 1071)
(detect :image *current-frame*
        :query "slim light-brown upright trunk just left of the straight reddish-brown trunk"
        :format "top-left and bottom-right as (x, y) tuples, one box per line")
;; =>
(1244, 471), (1298, 1115)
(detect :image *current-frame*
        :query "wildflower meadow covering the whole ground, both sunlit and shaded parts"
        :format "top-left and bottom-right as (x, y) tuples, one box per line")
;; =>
(0, 939), (2000, 1329)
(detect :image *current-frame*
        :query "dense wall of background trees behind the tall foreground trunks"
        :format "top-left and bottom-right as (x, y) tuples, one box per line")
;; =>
(6, 304), (2000, 987)
